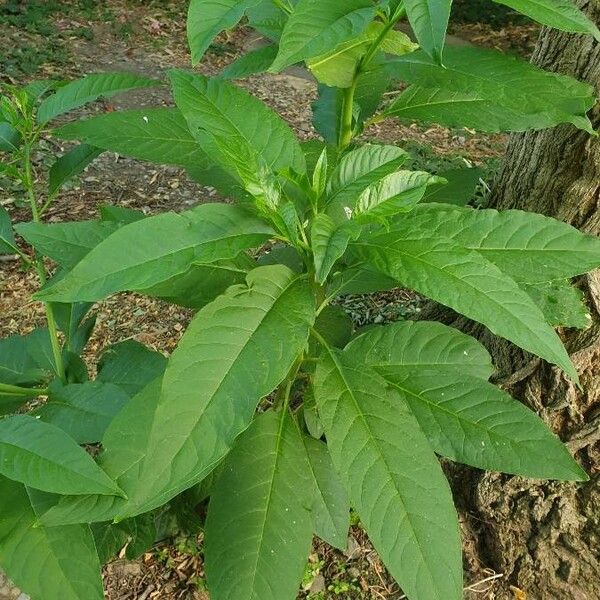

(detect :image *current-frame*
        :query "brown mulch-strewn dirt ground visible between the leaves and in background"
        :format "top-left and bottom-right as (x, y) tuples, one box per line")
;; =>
(0, 0), (536, 600)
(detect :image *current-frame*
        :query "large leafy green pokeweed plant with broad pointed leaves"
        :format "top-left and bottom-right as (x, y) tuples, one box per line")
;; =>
(0, 0), (600, 600)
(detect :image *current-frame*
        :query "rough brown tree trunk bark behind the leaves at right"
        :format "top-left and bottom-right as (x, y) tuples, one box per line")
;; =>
(429, 0), (600, 600)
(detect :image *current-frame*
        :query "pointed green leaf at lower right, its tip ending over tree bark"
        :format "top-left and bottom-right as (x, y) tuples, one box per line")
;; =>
(377, 366), (588, 481)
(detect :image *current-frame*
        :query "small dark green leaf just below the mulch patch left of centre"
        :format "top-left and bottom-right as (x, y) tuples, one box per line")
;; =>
(97, 340), (167, 397)
